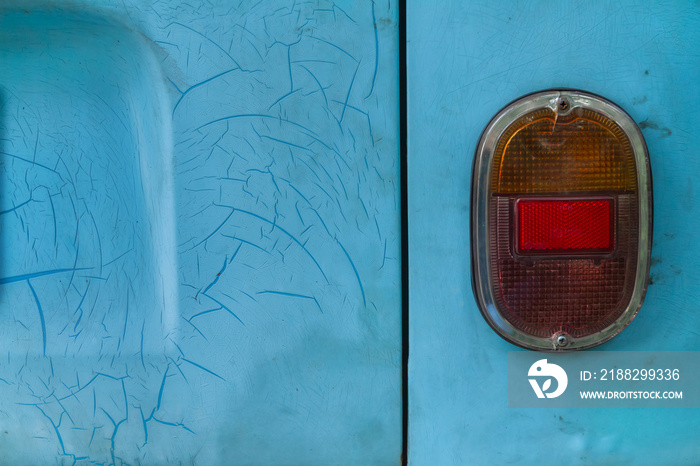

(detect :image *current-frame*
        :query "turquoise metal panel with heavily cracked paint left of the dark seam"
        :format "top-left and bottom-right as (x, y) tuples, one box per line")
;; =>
(0, 0), (401, 464)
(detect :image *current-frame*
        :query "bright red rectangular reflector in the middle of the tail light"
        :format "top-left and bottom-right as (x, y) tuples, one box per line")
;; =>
(516, 198), (614, 254)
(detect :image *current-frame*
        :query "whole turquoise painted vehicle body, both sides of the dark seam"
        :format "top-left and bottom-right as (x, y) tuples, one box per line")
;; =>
(0, 0), (700, 465)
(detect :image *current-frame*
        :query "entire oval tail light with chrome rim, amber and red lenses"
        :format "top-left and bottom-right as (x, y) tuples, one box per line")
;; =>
(472, 90), (652, 351)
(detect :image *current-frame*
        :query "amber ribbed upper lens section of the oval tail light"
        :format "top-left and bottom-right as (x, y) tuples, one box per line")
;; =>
(491, 108), (637, 194)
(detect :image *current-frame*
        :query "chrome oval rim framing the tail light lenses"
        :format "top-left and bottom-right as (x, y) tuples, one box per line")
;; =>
(471, 89), (653, 351)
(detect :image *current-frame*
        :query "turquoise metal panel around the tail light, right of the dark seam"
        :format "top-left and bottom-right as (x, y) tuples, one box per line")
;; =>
(407, 0), (700, 465)
